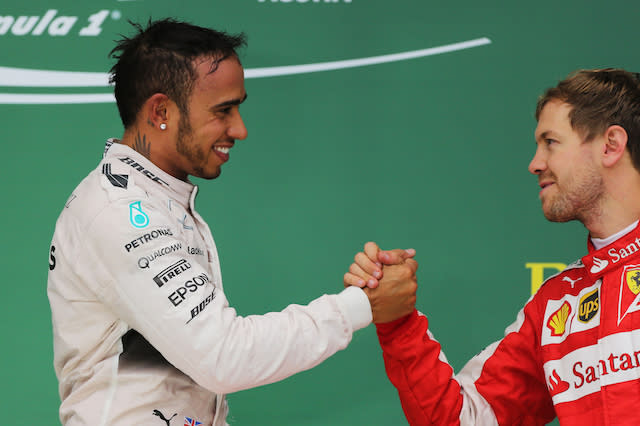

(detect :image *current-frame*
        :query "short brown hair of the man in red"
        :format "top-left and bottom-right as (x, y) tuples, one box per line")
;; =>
(536, 68), (640, 171)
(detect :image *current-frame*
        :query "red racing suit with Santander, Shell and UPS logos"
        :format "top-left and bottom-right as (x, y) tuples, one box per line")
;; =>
(377, 226), (640, 426)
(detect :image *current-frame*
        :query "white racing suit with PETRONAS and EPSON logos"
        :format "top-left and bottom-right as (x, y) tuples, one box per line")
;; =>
(48, 140), (371, 426)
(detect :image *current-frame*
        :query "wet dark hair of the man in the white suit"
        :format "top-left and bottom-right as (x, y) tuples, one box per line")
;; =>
(109, 19), (246, 128)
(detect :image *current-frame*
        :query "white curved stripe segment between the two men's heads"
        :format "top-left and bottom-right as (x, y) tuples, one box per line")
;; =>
(244, 37), (491, 78)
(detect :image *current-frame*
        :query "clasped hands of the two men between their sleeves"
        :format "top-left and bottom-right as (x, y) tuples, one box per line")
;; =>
(344, 242), (418, 324)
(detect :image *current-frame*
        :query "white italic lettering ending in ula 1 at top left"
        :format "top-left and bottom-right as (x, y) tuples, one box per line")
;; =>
(0, 9), (122, 37)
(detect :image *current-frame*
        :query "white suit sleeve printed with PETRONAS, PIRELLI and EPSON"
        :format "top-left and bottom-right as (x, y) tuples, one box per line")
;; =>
(79, 200), (371, 393)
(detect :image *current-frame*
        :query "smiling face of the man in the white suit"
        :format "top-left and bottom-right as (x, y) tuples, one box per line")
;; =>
(169, 57), (247, 180)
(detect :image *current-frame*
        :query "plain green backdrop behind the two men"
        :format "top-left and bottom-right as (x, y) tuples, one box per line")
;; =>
(0, 0), (640, 425)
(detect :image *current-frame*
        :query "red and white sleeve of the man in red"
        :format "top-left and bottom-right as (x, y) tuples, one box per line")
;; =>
(377, 301), (555, 425)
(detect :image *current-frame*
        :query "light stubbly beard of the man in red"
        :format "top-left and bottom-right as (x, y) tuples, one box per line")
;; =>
(542, 169), (605, 223)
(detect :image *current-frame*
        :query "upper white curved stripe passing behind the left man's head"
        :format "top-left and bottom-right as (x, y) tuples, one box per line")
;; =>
(0, 37), (491, 87)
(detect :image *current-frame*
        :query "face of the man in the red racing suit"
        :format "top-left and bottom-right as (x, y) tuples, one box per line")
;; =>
(529, 100), (605, 223)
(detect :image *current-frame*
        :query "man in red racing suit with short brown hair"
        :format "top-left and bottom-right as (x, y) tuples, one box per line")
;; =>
(345, 69), (640, 426)
